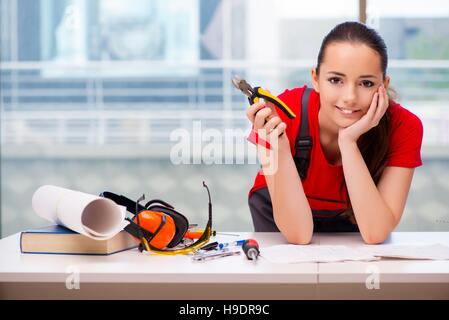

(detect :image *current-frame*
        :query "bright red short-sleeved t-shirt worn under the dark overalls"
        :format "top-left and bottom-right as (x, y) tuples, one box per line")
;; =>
(249, 86), (423, 210)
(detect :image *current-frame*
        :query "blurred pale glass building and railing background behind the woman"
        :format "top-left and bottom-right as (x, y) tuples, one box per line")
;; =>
(0, 0), (449, 237)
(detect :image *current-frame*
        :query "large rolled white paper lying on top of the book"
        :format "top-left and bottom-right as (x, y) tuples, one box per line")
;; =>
(32, 185), (127, 240)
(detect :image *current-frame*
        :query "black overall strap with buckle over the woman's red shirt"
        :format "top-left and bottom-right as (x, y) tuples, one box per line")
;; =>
(294, 88), (312, 180)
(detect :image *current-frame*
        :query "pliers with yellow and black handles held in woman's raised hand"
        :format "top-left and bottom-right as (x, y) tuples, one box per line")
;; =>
(232, 76), (296, 119)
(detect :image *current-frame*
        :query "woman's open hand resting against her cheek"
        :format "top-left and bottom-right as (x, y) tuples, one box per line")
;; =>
(338, 85), (388, 144)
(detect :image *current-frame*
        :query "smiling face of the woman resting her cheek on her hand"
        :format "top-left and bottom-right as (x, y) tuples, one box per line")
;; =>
(312, 42), (389, 128)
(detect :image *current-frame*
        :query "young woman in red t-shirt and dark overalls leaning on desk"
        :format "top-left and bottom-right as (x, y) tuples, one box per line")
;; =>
(247, 22), (423, 244)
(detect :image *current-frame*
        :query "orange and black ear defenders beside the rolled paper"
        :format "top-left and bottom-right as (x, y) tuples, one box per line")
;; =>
(100, 191), (189, 249)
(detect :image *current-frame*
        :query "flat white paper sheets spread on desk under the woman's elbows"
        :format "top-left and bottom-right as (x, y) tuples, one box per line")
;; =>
(260, 244), (449, 263)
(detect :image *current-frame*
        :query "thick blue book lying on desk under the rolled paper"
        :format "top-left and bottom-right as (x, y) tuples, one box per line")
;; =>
(20, 225), (138, 255)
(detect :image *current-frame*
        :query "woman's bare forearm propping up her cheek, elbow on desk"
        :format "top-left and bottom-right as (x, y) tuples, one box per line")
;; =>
(340, 142), (396, 244)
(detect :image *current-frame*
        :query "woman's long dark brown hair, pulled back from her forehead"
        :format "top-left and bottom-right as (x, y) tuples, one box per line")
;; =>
(316, 22), (394, 223)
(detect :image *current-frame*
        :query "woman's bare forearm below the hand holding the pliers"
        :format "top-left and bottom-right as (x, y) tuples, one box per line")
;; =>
(263, 152), (313, 244)
